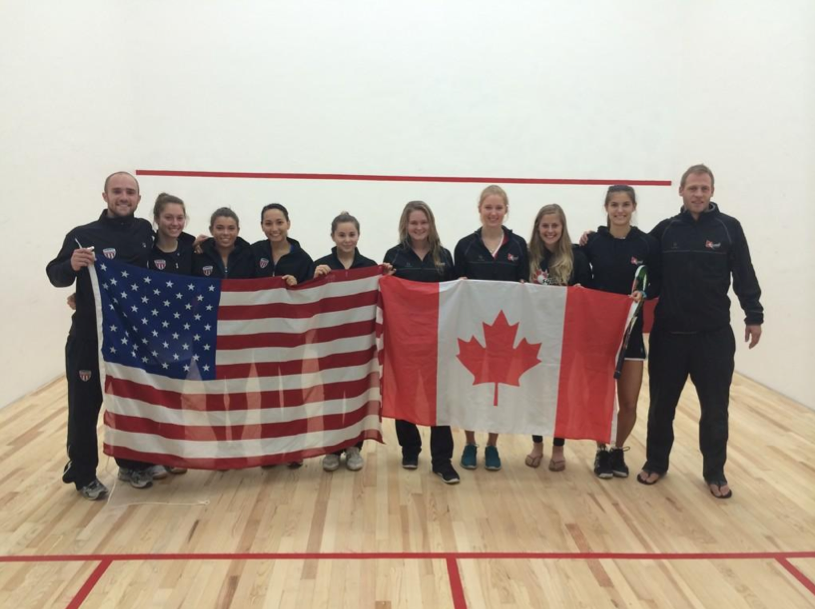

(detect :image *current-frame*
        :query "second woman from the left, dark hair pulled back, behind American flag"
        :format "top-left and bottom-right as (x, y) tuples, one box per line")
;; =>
(192, 207), (255, 279)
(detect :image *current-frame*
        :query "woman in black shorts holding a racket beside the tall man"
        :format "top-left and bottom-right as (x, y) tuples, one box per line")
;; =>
(582, 184), (661, 479)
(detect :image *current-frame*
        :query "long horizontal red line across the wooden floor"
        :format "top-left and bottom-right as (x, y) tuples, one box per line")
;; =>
(0, 551), (815, 563)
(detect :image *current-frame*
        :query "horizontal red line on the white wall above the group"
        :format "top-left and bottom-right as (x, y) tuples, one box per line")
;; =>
(136, 169), (672, 186)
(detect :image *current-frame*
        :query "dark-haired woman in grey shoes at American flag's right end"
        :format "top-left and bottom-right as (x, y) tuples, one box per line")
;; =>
(314, 211), (376, 472)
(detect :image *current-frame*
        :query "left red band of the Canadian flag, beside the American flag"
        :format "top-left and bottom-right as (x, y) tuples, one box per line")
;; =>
(379, 277), (439, 425)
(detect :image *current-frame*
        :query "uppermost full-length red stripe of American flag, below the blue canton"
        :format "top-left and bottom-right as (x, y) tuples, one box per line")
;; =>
(105, 372), (379, 412)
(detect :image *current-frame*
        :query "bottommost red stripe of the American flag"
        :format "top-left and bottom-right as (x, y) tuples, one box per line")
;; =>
(104, 429), (383, 470)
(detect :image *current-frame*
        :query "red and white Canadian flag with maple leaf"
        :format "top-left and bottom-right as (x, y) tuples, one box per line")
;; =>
(380, 277), (634, 442)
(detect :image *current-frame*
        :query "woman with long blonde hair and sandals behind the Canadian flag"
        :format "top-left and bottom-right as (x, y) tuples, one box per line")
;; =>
(525, 203), (591, 472)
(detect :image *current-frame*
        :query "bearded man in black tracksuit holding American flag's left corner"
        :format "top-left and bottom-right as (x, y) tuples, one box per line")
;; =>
(45, 172), (153, 500)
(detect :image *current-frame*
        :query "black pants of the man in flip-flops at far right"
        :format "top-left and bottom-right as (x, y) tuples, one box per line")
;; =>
(644, 326), (736, 482)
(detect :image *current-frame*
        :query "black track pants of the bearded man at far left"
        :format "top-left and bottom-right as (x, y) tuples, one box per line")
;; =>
(65, 334), (150, 488)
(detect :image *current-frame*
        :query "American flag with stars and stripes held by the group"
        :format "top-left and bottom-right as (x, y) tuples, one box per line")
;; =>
(91, 259), (382, 469)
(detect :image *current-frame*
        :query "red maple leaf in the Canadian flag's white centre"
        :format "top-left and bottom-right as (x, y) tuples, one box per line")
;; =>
(458, 311), (541, 406)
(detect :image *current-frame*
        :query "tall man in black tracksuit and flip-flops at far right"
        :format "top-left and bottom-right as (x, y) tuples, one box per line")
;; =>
(638, 165), (764, 499)
